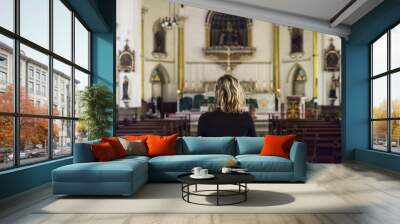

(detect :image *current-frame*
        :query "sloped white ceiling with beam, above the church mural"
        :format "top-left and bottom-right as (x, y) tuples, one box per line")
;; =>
(171, 0), (383, 37)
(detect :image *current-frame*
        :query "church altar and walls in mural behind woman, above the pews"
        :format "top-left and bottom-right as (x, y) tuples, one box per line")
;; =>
(116, 0), (341, 162)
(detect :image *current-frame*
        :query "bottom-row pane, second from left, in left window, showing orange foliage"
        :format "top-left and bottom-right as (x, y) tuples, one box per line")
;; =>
(19, 117), (49, 164)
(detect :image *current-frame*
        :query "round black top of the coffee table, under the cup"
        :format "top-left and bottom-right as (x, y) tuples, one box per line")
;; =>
(177, 173), (255, 184)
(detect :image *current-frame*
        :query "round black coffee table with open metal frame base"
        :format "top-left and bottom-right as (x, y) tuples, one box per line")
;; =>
(177, 173), (255, 206)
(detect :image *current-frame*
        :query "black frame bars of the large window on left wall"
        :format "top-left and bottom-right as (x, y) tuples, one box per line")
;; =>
(0, 0), (92, 172)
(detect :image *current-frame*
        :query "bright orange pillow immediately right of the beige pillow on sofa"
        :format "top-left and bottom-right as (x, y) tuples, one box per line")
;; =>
(146, 134), (178, 157)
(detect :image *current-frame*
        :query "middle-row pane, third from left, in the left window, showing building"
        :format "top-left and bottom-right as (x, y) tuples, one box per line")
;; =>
(52, 59), (72, 117)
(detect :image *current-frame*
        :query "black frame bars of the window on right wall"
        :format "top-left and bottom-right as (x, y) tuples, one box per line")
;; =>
(368, 21), (400, 154)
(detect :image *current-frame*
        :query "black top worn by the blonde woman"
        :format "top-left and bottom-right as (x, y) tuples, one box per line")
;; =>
(197, 110), (256, 137)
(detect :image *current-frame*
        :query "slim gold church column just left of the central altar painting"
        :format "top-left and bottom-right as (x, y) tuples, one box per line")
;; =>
(178, 17), (185, 96)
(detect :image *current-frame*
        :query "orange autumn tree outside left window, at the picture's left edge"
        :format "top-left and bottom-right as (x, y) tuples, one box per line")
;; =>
(0, 85), (59, 149)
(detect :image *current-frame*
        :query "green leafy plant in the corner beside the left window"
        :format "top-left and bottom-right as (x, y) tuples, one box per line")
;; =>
(79, 84), (113, 139)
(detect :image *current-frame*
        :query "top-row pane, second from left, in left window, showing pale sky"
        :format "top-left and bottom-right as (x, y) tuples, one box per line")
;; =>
(20, 0), (49, 48)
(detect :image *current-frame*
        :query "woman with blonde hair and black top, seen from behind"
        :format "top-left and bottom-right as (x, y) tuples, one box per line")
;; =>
(197, 75), (256, 137)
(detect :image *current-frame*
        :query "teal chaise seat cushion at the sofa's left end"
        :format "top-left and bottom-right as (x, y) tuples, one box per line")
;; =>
(52, 159), (147, 183)
